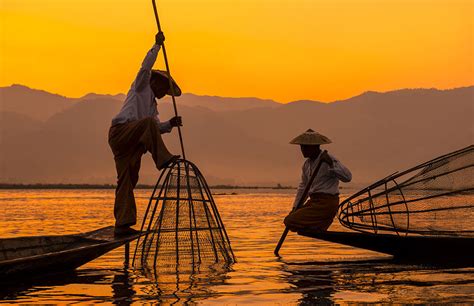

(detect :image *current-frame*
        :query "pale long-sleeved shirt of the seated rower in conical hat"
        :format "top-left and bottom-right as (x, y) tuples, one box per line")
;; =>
(293, 154), (352, 207)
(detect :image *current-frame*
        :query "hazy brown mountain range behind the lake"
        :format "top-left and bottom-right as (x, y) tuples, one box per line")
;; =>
(0, 85), (474, 186)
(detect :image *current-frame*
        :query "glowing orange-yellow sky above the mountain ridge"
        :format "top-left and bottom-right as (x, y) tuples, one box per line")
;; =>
(0, 0), (474, 102)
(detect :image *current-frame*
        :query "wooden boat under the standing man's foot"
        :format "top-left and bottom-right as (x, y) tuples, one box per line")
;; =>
(0, 226), (140, 280)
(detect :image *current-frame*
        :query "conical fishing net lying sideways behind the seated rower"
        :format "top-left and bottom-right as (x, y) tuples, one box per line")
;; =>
(339, 145), (474, 237)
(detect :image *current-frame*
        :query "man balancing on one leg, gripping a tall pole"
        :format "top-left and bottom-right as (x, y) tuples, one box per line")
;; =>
(109, 32), (182, 236)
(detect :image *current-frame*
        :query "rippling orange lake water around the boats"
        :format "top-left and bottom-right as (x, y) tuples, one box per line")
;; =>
(0, 190), (474, 305)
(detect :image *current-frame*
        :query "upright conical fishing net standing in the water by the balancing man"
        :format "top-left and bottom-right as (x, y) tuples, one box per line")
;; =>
(134, 160), (234, 277)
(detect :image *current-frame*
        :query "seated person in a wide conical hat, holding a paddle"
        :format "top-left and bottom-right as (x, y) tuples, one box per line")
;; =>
(284, 129), (352, 232)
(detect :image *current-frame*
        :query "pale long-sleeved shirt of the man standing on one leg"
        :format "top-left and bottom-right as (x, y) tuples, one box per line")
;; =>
(112, 45), (173, 133)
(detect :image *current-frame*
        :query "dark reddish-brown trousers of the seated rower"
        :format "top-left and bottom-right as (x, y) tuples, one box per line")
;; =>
(284, 193), (339, 232)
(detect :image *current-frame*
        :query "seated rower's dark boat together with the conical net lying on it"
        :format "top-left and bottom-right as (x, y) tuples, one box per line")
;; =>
(292, 145), (474, 266)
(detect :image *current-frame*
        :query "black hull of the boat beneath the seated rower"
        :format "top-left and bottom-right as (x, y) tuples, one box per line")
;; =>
(298, 231), (474, 266)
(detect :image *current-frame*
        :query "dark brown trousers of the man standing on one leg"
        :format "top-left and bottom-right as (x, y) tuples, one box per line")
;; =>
(109, 117), (172, 226)
